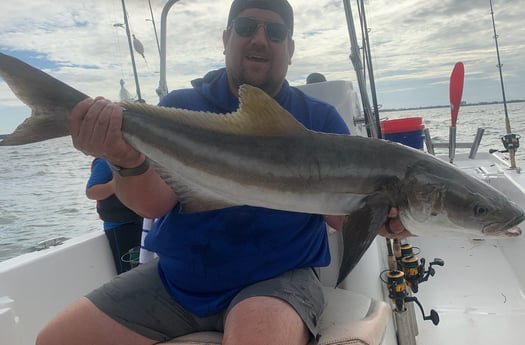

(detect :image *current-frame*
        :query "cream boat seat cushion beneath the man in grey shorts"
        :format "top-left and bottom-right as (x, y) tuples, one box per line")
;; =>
(162, 287), (391, 345)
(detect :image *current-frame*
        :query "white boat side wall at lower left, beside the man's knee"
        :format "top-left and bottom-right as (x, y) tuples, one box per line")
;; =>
(0, 231), (116, 345)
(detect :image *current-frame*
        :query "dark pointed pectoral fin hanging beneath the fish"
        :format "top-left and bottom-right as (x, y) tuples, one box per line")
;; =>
(336, 193), (390, 286)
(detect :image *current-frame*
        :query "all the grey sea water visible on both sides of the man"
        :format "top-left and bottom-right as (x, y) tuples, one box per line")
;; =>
(0, 103), (525, 261)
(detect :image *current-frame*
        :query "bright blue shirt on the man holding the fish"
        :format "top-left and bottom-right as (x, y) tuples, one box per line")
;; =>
(145, 69), (349, 317)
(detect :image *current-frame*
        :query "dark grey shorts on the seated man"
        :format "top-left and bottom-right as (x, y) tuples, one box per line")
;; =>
(86, 260), (325, 342)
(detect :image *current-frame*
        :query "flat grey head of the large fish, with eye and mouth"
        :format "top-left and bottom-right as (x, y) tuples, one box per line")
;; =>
(400, 159), (525, 238)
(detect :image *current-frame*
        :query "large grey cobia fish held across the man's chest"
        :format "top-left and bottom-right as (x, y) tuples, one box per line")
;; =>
(0, 54), (525, 284)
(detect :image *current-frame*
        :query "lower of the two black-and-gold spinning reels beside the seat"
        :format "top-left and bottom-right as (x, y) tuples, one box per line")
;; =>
(381, 270), (439, 326)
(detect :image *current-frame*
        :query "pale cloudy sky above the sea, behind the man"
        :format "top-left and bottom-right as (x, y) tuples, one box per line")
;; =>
(0, 0), (525, 134)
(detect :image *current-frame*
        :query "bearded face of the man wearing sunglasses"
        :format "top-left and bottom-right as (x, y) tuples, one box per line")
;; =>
(223, 8), (295, 96)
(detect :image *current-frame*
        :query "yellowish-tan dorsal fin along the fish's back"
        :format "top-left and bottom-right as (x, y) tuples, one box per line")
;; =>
(121, 85), (308, 136)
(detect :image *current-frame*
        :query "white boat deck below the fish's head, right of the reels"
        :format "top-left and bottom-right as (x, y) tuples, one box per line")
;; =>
(410, 234), (525, 345)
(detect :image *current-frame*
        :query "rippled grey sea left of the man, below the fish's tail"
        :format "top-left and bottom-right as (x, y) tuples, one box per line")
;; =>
(0, 137), (102, 261)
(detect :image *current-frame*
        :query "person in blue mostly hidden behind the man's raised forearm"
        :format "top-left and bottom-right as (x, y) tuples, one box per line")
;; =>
(86, 158), (142, 274)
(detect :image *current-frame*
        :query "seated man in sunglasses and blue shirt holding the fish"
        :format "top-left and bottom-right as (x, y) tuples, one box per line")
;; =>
(37, 0), (406, 345)
